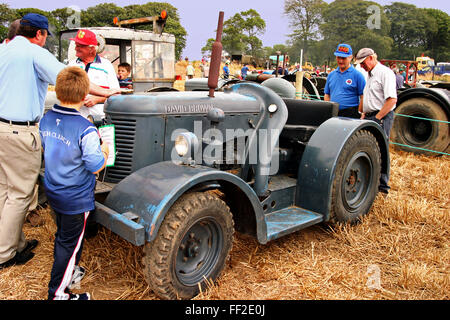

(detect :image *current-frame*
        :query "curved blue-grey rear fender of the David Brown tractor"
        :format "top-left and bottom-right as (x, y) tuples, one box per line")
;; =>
(295, 117), (390, 221)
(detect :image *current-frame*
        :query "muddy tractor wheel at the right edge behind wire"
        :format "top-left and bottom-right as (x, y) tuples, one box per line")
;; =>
(392, 98), (450, 156)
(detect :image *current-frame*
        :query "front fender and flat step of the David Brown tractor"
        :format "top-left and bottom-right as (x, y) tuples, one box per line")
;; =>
(100, 161), (323, 244)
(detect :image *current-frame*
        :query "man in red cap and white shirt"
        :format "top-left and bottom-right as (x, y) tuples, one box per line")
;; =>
(69, 29), (120, 119)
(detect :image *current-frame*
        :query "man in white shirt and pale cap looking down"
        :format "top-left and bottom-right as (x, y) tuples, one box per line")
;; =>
(356, 48), (397, 194)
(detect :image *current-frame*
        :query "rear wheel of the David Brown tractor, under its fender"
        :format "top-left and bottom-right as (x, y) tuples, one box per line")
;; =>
(330, 130), (381, 223)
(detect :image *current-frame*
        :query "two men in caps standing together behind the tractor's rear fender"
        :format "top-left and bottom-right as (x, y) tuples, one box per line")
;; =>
(324, 44), (397, 194)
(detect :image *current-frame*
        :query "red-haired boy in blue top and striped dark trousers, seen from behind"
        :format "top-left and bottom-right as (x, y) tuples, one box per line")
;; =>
(39, 67), (109, 300)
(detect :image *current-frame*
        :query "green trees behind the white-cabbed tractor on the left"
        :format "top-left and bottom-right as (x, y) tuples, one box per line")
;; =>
(0, 2), (187, 59)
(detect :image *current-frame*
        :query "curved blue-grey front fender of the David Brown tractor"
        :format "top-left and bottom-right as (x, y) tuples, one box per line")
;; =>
(105, 161), (267, 241)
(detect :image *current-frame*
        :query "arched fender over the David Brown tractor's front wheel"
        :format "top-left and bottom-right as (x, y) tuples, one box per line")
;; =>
(104, 161), (266, 242)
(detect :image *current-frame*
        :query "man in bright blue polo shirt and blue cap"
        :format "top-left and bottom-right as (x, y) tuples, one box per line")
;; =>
(324, 43), (366, 119)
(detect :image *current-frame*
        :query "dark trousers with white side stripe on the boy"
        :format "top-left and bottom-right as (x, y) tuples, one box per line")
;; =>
(48, 211), (89, 300)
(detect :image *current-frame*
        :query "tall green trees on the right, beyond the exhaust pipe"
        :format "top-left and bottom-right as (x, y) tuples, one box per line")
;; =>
(202, 0), (450, 65)
